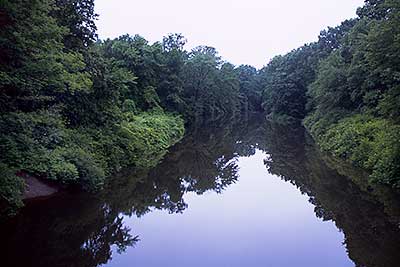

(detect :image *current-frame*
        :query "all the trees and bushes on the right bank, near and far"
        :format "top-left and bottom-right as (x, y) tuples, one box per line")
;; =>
(260, 0), (400, 191)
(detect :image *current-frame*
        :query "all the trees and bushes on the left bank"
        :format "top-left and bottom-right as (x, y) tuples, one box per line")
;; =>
(0, 0), (261, 214)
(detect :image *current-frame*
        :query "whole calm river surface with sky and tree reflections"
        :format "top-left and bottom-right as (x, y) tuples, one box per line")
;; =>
(0, 118), (400, 267)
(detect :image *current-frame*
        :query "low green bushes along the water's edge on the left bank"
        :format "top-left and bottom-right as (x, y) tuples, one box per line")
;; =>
(0, 111), (184, 213)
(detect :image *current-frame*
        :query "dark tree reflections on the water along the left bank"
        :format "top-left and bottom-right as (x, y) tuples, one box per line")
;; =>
(0, 114), (266, 267)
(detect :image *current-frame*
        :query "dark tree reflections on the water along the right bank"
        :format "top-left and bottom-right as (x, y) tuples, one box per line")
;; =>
(262, 122), (400, 267)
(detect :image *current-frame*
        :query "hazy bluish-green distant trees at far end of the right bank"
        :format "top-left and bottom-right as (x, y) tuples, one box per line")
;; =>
(260, 20), (355, 121)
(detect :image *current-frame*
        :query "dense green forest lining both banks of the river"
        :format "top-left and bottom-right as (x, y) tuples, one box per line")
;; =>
(0, 0), (400, 216)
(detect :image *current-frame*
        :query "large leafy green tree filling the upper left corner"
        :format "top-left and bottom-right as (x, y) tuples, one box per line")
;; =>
(0, 0), (91, 112)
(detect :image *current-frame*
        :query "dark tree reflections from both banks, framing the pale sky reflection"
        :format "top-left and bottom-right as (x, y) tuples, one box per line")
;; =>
(0, 117), (400, 267)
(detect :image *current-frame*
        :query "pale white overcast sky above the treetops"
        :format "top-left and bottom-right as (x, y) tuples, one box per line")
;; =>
(95, 0), (363, 68)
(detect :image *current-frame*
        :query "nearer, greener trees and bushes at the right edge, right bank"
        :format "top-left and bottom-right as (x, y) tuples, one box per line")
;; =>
(304, 0), (400, 187)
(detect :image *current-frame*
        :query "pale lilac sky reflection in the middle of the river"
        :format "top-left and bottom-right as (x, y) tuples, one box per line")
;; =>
(107, 151), (354, 267)
